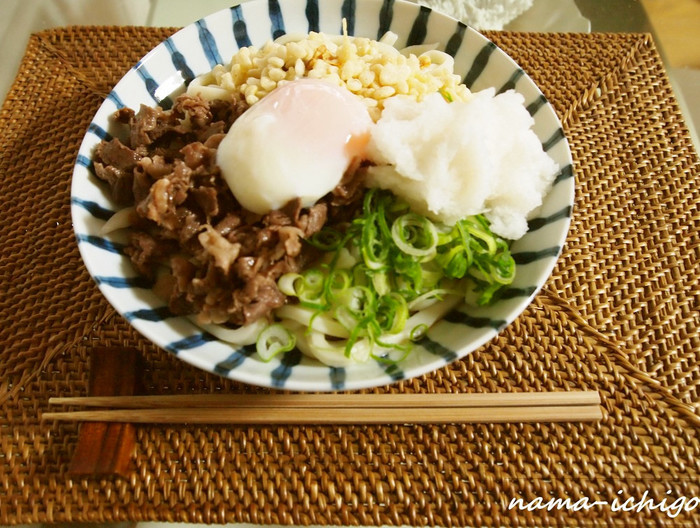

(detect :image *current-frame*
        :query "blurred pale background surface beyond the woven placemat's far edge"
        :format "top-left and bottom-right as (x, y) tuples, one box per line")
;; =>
(0, 0), (700, 146)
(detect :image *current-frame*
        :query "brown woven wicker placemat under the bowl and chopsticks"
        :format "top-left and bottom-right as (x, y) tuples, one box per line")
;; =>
(0, 27), (700, 526)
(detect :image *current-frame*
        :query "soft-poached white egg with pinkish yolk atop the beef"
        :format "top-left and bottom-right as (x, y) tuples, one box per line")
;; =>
(217, 79), (373, 214)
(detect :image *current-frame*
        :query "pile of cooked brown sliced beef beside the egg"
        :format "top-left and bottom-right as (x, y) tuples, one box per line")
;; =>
(95, 96), (370, 325)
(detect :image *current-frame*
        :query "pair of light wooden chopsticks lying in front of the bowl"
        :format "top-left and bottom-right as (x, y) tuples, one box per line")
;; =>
(42, 391), (602, 425)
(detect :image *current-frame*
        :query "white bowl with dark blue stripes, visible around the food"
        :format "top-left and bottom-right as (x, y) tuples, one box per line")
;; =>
(71, 0), (574, 391)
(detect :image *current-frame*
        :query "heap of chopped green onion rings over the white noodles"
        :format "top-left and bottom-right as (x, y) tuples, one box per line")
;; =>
(277, 188), (515, 365)
